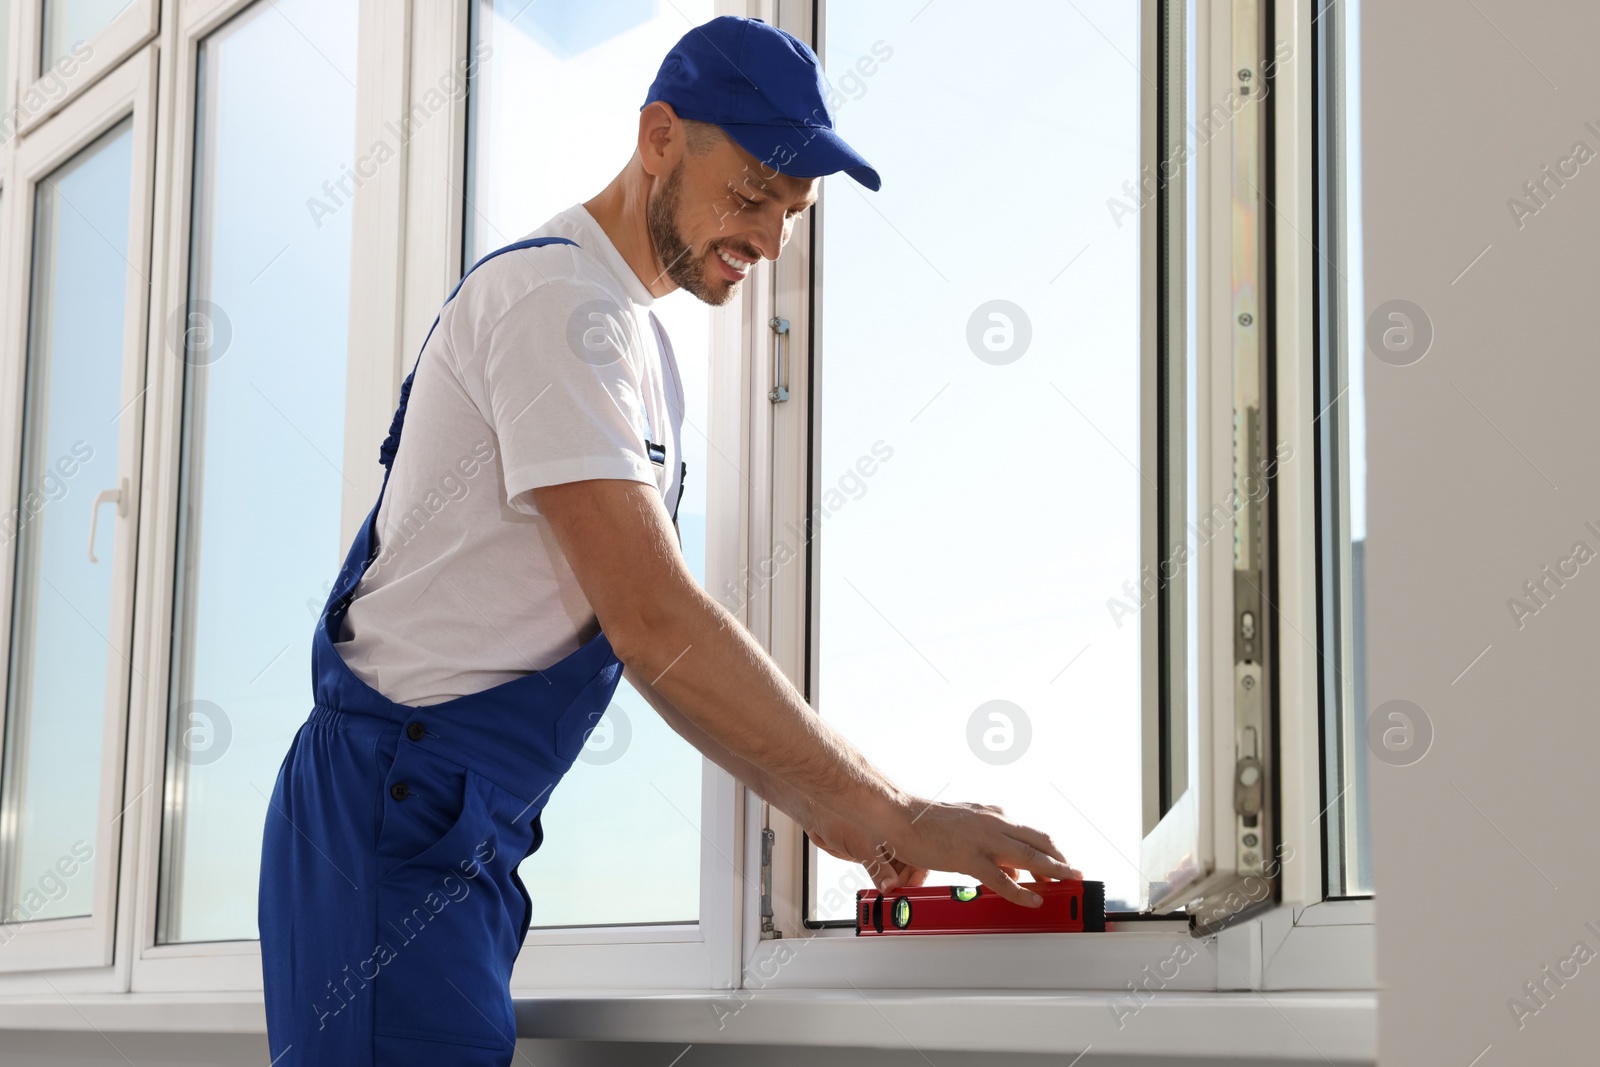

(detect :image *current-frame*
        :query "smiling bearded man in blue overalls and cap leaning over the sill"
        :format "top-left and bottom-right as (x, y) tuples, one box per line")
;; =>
(259, 18), (1082, 1067)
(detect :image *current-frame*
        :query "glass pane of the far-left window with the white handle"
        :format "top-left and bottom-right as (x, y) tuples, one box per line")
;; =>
(0, 120), (133, 921)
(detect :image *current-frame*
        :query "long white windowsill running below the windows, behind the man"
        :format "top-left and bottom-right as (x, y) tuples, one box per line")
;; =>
(0, 989), (1378, 1062)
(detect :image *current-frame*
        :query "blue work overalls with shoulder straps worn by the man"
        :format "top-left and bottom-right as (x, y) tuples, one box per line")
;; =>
(258, 237), (682, 1067)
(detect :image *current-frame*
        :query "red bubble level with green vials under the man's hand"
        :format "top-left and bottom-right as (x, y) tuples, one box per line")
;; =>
(856, 880), (1106, 937)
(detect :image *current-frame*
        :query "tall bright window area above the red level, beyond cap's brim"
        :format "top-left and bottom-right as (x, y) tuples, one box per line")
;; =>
(810, 0), (1149, 920)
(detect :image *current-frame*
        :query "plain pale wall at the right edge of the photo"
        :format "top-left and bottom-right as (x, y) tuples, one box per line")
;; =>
(1362, 0), (1600, 1067)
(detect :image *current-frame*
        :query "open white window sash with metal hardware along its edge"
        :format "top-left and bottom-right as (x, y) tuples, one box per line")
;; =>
(1141, 0), (1282, 933)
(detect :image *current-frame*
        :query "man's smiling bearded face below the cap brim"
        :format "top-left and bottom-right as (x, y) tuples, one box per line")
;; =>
(646, 133), (818, 306)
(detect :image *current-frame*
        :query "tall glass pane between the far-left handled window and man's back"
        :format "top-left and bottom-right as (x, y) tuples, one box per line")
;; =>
(157, 0), (358, 942)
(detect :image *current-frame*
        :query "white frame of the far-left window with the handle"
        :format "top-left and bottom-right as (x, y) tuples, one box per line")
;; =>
(0, 41), (155, 989)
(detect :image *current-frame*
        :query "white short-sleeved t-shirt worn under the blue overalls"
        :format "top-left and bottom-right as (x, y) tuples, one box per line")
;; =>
(338, 203), (683, 705)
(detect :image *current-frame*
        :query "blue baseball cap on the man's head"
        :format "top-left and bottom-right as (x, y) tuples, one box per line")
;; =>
(638, 14), (883, 190)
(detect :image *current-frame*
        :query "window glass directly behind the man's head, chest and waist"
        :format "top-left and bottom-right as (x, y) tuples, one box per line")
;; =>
(466, 0), (710, 926)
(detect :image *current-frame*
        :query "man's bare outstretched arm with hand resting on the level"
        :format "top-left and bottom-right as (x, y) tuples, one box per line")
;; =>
(533, 478), (1080, 904)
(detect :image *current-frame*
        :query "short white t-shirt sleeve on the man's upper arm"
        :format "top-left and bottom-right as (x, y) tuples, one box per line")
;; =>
(462, 278), (656, 515)
